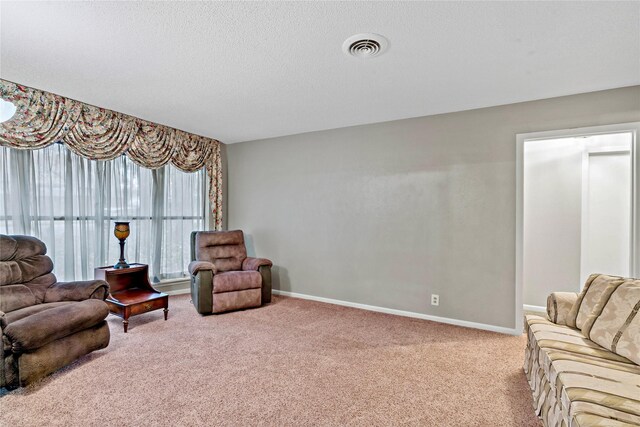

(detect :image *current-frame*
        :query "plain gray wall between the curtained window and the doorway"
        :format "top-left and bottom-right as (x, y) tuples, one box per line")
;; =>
(226, 86), (640, 328)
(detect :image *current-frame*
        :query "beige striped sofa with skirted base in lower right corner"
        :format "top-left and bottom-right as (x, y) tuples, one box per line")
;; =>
(524, 274), (640, 427)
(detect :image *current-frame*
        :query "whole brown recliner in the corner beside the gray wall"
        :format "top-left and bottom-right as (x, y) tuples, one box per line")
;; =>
(189, 230), (273, 314)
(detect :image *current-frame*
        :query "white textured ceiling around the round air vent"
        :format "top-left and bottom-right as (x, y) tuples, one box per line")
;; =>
(0, 1), (640, 143)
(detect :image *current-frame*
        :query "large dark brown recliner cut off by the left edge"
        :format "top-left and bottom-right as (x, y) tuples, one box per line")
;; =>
(0, 234), (110, 388)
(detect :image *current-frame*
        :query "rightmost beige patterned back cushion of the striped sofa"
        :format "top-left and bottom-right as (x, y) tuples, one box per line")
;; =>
(589, 279), (640, 364)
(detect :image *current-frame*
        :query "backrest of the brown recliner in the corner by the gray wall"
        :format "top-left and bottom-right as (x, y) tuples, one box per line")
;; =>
(191, 230), (247, 271)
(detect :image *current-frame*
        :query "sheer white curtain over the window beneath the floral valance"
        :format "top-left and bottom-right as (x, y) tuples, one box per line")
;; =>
(0, 144), (205, 281)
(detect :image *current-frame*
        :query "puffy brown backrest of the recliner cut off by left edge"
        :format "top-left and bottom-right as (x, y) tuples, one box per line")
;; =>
(0, 234), (56, 312)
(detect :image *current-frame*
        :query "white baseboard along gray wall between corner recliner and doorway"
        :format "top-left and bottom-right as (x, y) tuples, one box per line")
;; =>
(272, 289), (520, 335)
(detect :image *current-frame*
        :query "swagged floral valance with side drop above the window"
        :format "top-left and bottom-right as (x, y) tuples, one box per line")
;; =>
(0, 79), (222, 230)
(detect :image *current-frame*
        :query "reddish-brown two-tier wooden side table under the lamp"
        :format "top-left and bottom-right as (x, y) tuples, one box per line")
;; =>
(94, 264), (169, 333)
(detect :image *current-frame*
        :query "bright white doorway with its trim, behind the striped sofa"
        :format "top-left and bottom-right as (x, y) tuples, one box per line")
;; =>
(516, 123), (640, 332)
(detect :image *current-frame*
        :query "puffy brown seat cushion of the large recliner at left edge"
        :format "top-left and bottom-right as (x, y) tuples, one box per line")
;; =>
(4, 299), (109, 353)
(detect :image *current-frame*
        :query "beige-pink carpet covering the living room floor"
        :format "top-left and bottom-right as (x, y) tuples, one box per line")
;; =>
(0, 295), (541, 427)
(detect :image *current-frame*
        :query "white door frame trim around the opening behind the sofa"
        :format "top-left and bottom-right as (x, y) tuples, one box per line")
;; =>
(515, 122), (640, 334)
